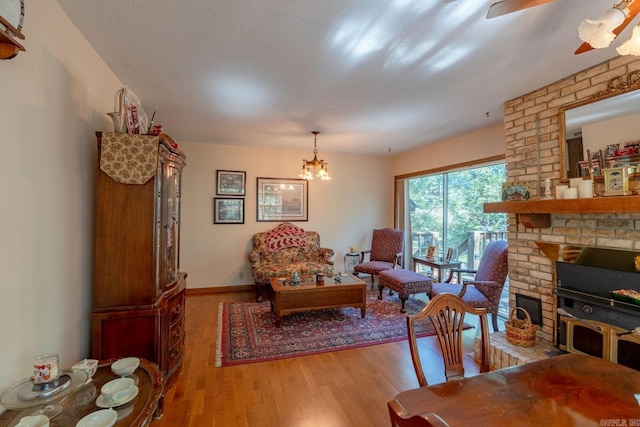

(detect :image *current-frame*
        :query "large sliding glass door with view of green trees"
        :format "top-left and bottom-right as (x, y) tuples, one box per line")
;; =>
(404, 163), (509, 320)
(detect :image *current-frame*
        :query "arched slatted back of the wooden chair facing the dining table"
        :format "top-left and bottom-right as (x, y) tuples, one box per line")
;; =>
(407, 294), (489, 387)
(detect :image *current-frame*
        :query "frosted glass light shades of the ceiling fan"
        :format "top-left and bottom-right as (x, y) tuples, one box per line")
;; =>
(578, 0), (640, 55)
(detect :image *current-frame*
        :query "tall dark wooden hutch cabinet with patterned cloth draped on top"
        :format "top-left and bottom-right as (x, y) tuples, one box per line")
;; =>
(92, 132), (187, 387)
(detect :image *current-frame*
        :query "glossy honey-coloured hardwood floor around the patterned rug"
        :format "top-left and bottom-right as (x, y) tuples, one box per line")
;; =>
(151, 292), (478, 427)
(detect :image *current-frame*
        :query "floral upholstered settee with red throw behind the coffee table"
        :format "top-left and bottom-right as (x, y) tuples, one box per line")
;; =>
(249, 222), (334, 302)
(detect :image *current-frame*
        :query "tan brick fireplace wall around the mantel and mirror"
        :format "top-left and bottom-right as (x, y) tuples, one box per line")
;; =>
(504, 56), (640, 343)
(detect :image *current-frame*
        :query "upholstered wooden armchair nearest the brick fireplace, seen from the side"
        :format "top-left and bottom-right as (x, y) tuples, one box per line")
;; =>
(431, 240), (509, 331)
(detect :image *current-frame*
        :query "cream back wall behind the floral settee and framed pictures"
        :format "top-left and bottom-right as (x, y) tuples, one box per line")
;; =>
(180, 143), (393, 289)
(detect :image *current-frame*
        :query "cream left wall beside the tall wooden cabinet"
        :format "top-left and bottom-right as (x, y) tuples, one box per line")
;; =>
(0, 0), (120, 398)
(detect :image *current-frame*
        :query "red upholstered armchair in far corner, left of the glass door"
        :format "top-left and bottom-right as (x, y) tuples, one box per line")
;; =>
(353, 228), (404, 289)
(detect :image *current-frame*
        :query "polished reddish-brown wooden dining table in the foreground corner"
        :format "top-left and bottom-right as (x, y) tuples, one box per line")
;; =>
(388, 353), (640, 427)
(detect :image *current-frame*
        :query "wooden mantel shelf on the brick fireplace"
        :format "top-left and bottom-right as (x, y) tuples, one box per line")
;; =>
(484, 195), (640, 228)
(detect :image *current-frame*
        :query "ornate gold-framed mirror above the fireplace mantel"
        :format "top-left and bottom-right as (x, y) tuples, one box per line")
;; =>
(558, 71), (640, 182)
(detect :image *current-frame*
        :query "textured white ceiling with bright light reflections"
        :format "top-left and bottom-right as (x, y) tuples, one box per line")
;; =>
(57, 0), (620, 154)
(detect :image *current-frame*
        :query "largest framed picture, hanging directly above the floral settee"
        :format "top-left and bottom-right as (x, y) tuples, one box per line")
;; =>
(256, 177), (309, 222)
